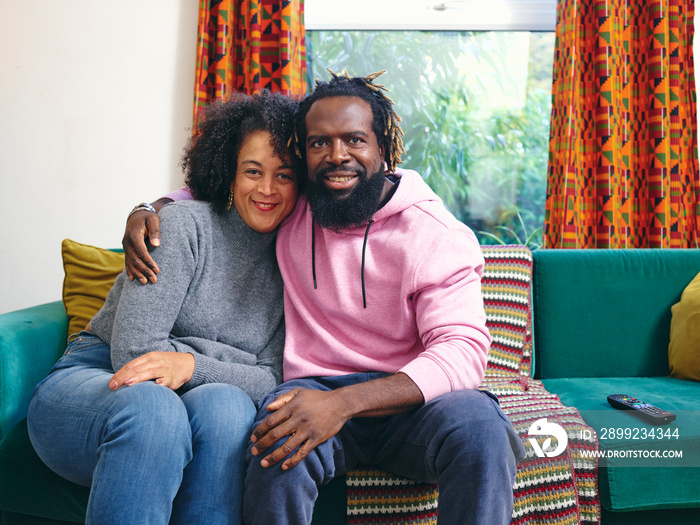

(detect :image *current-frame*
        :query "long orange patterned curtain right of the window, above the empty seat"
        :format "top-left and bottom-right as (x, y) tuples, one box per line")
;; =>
(544, 0), (700, 248)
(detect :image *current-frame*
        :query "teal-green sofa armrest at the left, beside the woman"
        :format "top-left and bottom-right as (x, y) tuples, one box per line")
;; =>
(0, 301), (68, 439)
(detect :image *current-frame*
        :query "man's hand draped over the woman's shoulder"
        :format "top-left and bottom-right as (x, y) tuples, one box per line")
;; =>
(122, 199), (171, 284)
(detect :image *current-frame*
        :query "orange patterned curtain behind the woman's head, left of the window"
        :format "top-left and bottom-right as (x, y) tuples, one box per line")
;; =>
(194, 0), (306, 122)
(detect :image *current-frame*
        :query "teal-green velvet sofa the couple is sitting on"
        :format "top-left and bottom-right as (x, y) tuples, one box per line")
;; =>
(0, 250), (700, 525)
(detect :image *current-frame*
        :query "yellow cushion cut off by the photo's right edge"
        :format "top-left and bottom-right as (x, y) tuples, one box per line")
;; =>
(668, 273), (700, 381)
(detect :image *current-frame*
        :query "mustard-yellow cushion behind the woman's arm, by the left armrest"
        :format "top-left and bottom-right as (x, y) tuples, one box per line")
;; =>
(61, 239), (124, 335)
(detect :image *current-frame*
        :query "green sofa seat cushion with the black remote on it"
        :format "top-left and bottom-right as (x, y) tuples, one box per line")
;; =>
(543, 377), (700, 511)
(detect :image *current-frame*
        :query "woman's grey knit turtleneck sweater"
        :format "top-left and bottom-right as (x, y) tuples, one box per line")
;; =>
(91, 201), (284, 401)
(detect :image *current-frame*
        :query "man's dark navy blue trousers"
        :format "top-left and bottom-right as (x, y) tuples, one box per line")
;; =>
(243, 373), (525, 525)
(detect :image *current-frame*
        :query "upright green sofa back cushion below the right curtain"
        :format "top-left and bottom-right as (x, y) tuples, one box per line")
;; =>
(532, 249), (700, 379)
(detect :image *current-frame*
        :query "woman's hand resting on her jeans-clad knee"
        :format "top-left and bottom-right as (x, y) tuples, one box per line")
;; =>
(109, 352), (194, 390)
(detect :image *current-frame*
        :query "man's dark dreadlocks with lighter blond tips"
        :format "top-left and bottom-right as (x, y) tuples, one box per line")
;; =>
(294, 69), (406, 173)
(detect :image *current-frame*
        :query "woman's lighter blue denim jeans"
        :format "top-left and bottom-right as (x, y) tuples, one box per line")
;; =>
(27, 332), (255, 524)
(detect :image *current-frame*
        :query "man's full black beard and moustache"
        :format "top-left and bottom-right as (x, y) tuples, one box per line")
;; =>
(306, 164), (386, 231)
